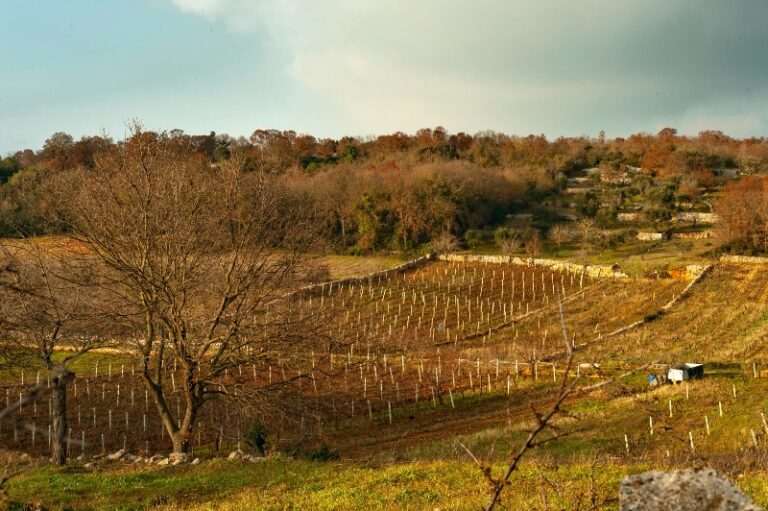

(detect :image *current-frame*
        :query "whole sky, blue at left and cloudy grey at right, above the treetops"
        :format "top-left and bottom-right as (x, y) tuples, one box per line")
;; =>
(0, 0), (768, 154)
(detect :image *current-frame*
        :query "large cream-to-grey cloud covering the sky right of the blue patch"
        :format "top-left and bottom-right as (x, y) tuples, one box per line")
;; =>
(165, 0), (768, 138)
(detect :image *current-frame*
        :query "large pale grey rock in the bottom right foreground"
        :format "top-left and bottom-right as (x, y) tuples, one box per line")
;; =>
(619, 468), (760, 511)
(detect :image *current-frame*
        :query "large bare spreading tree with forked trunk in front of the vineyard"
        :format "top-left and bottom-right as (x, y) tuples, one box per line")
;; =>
(51, 129), (320, 453)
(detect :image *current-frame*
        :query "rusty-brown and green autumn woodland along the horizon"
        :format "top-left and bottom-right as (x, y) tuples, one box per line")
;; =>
(0, 127), (768, 253)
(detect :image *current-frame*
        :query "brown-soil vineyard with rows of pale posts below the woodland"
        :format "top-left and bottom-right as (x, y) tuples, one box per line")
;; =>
(0, 262), (686, 457)
